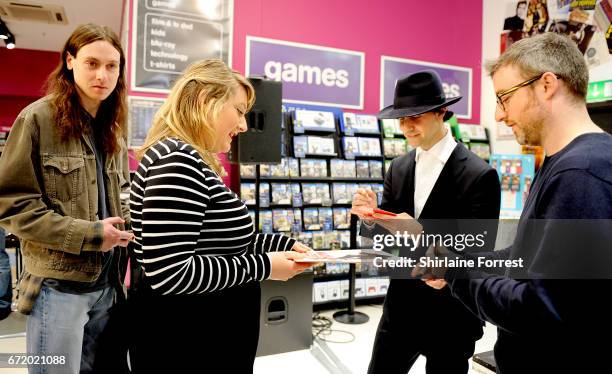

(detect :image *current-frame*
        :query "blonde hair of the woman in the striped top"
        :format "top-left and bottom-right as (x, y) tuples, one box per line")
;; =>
(136, 59), (255, 176)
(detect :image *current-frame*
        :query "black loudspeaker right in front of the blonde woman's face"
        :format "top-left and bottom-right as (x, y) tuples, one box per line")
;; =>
(229, 77), (283, 164)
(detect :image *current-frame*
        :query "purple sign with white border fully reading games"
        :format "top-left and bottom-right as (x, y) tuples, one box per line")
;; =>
(245, 36), (365, 109)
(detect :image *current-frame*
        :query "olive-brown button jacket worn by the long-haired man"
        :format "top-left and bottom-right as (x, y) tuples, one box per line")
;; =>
(0, 97), (130, 313)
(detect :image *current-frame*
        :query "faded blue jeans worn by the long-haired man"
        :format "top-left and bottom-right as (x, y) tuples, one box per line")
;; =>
(26, 285), (115, 374)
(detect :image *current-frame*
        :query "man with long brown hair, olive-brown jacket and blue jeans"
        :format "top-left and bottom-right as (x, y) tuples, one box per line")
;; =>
(0, 24), (131, 374)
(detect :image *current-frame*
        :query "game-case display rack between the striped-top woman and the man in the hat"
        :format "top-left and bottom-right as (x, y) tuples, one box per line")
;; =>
(240, 105), (388, 296)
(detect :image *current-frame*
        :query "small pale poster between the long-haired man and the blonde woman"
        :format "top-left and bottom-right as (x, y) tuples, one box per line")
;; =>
(128, 96), (164, 148)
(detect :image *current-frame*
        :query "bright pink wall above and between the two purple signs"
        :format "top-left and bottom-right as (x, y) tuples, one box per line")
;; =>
(232, 0), (482, 123)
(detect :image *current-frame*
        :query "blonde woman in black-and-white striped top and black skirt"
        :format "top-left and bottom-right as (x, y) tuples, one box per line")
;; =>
(130, 60), (309, 373)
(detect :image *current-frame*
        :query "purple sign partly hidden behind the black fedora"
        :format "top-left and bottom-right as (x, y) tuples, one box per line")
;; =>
(380, 56), (472, 119)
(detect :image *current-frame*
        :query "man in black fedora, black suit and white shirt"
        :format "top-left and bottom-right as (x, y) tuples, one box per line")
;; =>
(352, 70), (500, 374)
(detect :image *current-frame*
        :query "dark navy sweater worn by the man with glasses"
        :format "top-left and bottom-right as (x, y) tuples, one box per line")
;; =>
(445, 134), (612, 374)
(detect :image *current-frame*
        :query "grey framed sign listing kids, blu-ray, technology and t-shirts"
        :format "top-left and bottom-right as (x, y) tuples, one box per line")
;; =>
(130, 0), (233, 93)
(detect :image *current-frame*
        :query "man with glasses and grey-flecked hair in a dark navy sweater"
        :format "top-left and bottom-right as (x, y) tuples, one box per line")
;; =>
(424, 33), (612, 374)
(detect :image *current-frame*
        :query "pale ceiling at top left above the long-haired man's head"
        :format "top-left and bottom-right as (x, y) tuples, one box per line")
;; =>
(4, 0), (127, 52)
